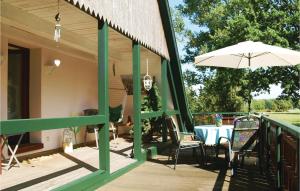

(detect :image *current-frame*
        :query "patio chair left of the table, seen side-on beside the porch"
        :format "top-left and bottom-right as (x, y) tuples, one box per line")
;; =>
(165, 118), (204, 170)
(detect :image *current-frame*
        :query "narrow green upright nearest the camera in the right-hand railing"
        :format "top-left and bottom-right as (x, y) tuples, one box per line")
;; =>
(276, 126), (282, 189)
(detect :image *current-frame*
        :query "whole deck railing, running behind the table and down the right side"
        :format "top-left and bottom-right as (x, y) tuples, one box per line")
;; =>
(193, 112), (300, 191)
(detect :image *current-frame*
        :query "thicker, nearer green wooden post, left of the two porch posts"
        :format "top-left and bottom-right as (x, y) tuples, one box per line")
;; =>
(98, 20), (110, 174)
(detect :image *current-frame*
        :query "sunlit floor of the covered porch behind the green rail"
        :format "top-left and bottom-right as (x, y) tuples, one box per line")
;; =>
(0, 138), (135, 191)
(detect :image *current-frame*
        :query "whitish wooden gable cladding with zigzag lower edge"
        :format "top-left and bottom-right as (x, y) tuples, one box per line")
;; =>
(66, 0), (170, 59)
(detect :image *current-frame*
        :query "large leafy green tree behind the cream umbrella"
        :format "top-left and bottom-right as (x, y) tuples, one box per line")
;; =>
(175, 0), (300, 110)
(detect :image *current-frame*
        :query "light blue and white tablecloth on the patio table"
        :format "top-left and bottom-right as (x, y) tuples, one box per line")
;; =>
(194, 125), (233, 145)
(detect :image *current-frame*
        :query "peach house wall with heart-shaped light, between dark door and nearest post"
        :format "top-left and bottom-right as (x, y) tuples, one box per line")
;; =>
(41, 48), (98, 150)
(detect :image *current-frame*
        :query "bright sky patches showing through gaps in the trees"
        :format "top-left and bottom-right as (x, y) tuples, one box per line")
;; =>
(169, 0), (282, 99)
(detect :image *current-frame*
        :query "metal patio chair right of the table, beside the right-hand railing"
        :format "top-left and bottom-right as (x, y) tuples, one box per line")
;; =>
(216, 115), (260, 175)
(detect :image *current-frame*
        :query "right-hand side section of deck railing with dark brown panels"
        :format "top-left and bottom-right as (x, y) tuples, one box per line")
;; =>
(261, 115), (300, 191)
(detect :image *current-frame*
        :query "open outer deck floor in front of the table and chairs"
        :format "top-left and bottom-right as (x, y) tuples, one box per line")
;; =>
(98, 149), (275, 191)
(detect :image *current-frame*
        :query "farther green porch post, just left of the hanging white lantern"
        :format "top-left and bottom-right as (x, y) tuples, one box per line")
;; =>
(132, 41), (142, 160)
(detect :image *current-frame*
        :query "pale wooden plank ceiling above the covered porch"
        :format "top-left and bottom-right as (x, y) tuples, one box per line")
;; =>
(0, 0), (160, 74)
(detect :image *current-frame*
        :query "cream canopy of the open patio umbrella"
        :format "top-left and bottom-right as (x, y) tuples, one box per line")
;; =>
(195, 41), (300, 68)
